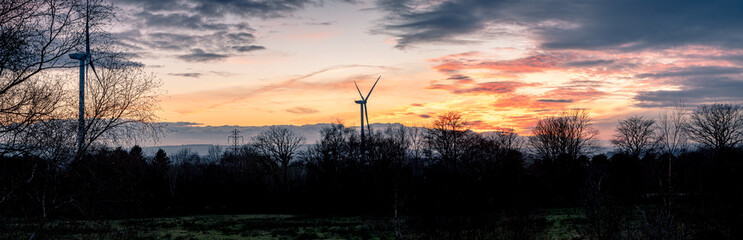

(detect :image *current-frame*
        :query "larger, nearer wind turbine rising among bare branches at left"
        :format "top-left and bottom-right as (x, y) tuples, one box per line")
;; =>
(69, 0), (101, 156)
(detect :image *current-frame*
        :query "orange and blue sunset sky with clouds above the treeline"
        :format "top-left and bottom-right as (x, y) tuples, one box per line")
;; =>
(110, 0), (743, 144)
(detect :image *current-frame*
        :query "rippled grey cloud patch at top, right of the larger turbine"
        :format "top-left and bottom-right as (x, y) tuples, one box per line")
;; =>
(116, 0), (364, 62)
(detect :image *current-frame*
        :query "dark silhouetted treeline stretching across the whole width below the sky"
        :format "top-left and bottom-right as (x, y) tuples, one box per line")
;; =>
(0, 104), (743, 239)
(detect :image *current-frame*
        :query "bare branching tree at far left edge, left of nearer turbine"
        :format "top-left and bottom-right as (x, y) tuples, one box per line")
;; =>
(0, 0), (113, 154)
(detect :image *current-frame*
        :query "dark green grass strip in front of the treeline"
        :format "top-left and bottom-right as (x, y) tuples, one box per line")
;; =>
(0, 209), (586, 239)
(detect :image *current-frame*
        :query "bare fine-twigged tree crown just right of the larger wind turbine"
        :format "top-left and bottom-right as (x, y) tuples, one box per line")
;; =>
(79, 56), (162, 149)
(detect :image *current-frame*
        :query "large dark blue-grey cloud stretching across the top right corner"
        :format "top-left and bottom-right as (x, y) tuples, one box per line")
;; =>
(376, 0), (743, 50)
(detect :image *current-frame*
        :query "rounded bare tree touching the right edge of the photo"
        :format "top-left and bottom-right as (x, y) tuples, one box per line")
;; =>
(687, 103), (743, 152)
